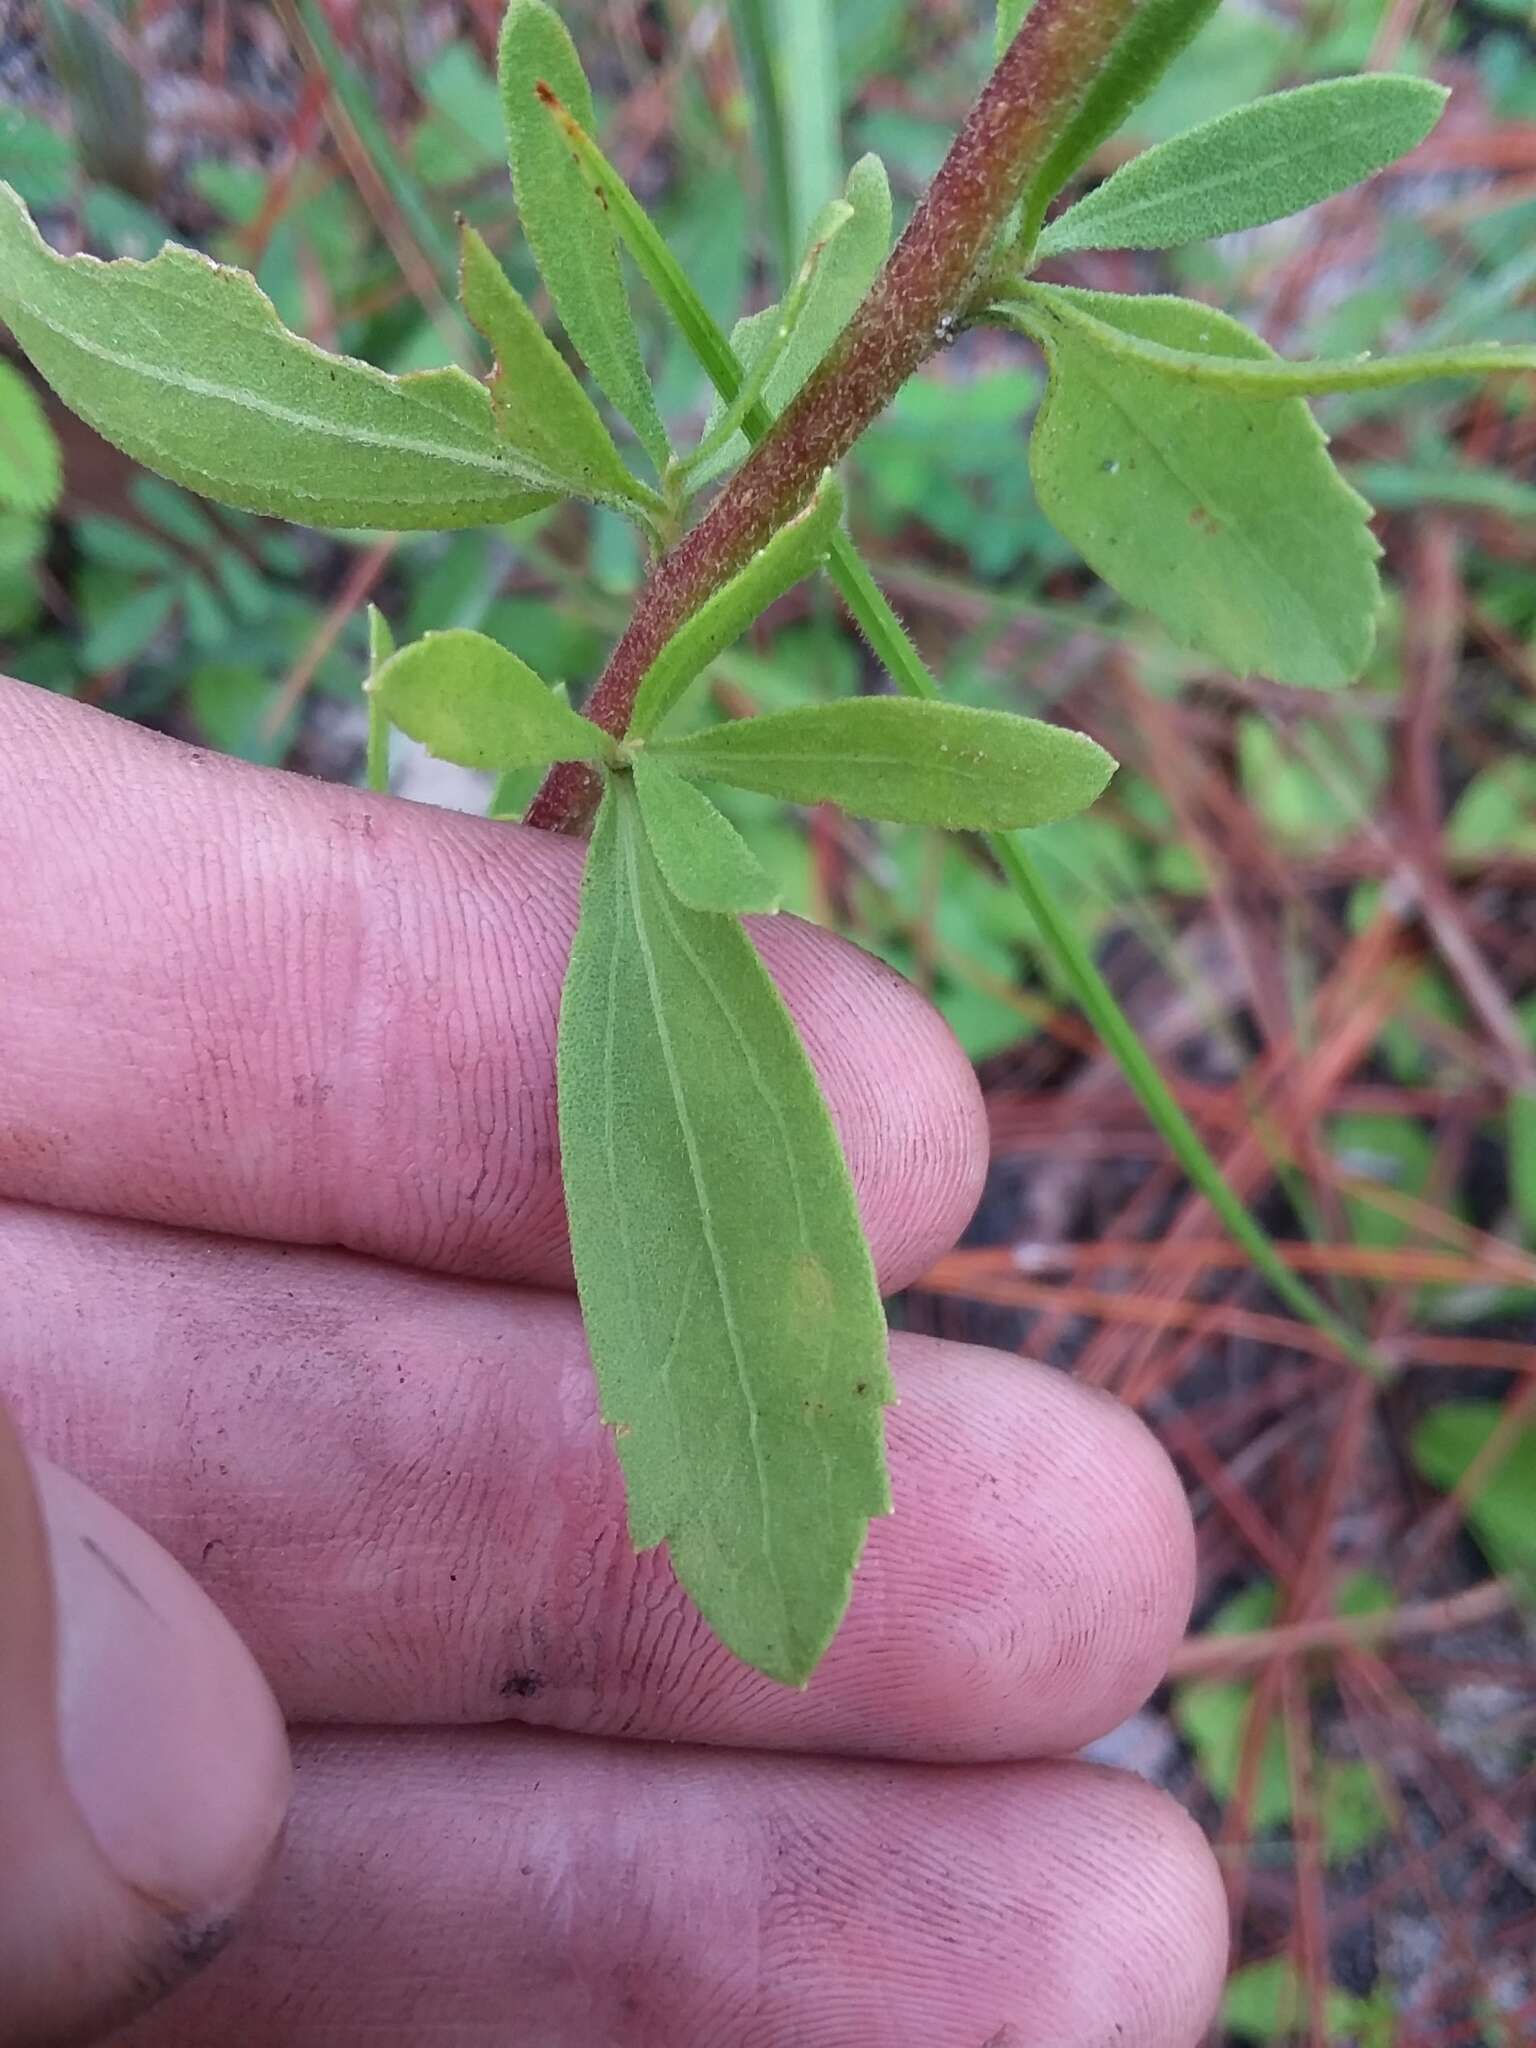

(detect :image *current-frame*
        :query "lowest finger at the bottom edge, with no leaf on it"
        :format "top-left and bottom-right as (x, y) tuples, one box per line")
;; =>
(123, 1731), (1225, 2048)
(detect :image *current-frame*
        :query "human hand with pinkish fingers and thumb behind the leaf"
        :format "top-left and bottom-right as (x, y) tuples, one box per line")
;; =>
(0, 684), (1225, 2048)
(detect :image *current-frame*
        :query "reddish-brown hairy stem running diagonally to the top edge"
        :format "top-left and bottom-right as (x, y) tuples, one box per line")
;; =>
(528, 0), (1141, 831)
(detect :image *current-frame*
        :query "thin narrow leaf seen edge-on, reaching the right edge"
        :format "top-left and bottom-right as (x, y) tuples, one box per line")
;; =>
(995, 285), (1536, 399)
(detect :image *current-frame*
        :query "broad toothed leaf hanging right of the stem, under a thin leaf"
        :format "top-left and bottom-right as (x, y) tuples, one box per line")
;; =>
(1018, 295), (1380, 688)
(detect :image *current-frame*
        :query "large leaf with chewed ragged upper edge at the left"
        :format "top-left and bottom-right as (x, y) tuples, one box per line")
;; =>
(0, 184), (555, 528)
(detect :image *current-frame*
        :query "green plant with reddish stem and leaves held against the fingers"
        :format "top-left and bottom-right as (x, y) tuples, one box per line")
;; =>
(0, 0), (1536, 1683)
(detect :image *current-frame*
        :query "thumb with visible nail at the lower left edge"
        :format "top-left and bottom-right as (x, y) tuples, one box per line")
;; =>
(0, 1409), (289, 2048)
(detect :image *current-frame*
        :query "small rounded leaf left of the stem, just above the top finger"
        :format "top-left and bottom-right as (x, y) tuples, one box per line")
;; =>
(369, 627), (614, 770)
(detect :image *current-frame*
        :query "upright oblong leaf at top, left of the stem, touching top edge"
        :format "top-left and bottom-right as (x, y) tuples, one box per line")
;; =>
(500, 0), (672, 469)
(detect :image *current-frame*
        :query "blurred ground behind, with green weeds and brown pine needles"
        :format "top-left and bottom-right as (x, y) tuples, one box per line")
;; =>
(0, 0), (1536, 2048)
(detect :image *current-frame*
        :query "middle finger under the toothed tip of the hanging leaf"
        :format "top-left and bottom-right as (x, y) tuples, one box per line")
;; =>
(0, 1208), (1192, 1757)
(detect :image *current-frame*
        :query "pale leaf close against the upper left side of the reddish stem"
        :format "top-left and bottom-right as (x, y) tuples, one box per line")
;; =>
(700, 156), (891, 481)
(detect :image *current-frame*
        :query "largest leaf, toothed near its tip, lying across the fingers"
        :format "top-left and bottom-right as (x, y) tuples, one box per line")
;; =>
(559, 776), (893, 1686)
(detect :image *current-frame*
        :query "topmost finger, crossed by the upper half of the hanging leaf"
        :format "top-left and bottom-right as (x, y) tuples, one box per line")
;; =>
(0, 682), (985, 1288)
